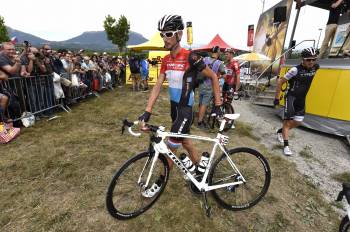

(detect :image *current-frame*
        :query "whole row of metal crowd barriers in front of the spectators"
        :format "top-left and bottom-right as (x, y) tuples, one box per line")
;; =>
(0, 70), (119, 125)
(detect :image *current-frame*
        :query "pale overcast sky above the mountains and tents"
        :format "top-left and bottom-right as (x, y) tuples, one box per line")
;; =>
(0, 0), (328, 48)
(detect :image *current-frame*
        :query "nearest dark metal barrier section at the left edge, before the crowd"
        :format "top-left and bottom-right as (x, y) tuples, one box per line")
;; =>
(0, 75), (68, 121)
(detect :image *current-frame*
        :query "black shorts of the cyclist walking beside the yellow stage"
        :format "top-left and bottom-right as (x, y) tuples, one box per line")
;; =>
(283, 94), (305, 122)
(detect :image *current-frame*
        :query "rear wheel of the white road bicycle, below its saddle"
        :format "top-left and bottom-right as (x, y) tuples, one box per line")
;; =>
(208, 147), (271, 211)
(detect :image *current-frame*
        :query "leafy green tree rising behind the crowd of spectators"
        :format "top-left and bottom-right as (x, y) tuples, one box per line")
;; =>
(103, 15), (130, 52)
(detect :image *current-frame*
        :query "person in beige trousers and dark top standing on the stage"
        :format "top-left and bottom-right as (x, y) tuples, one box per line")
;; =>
(319, 0), (343, 59)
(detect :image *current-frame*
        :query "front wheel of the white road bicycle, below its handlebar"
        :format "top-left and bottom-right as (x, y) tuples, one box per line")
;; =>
(106, 152), (169, 220)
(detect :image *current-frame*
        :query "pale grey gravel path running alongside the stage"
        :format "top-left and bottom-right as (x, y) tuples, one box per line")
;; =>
(233, 100), (350, 207)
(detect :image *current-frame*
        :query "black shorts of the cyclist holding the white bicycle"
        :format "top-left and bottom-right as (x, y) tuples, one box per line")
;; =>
(170, 101), (193, 141)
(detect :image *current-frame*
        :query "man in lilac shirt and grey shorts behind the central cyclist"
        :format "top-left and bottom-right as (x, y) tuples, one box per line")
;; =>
(197, 46), (225, 129)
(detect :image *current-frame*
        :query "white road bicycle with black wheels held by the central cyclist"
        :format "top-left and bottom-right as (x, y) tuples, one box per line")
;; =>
(106, 114), (271, 220)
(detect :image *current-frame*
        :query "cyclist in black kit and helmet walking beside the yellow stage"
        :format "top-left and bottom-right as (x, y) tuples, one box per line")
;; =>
(274, 47), (320, 156)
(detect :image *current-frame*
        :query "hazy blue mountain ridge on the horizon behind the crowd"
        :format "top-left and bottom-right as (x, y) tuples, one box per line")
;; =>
(7, 27), (147, 51)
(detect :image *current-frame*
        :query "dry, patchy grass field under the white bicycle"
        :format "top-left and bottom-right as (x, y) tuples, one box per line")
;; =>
(0, 89), (339, 232)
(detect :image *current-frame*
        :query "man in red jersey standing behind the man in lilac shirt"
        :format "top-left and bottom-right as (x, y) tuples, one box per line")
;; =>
(222, 48), (241, 95)
